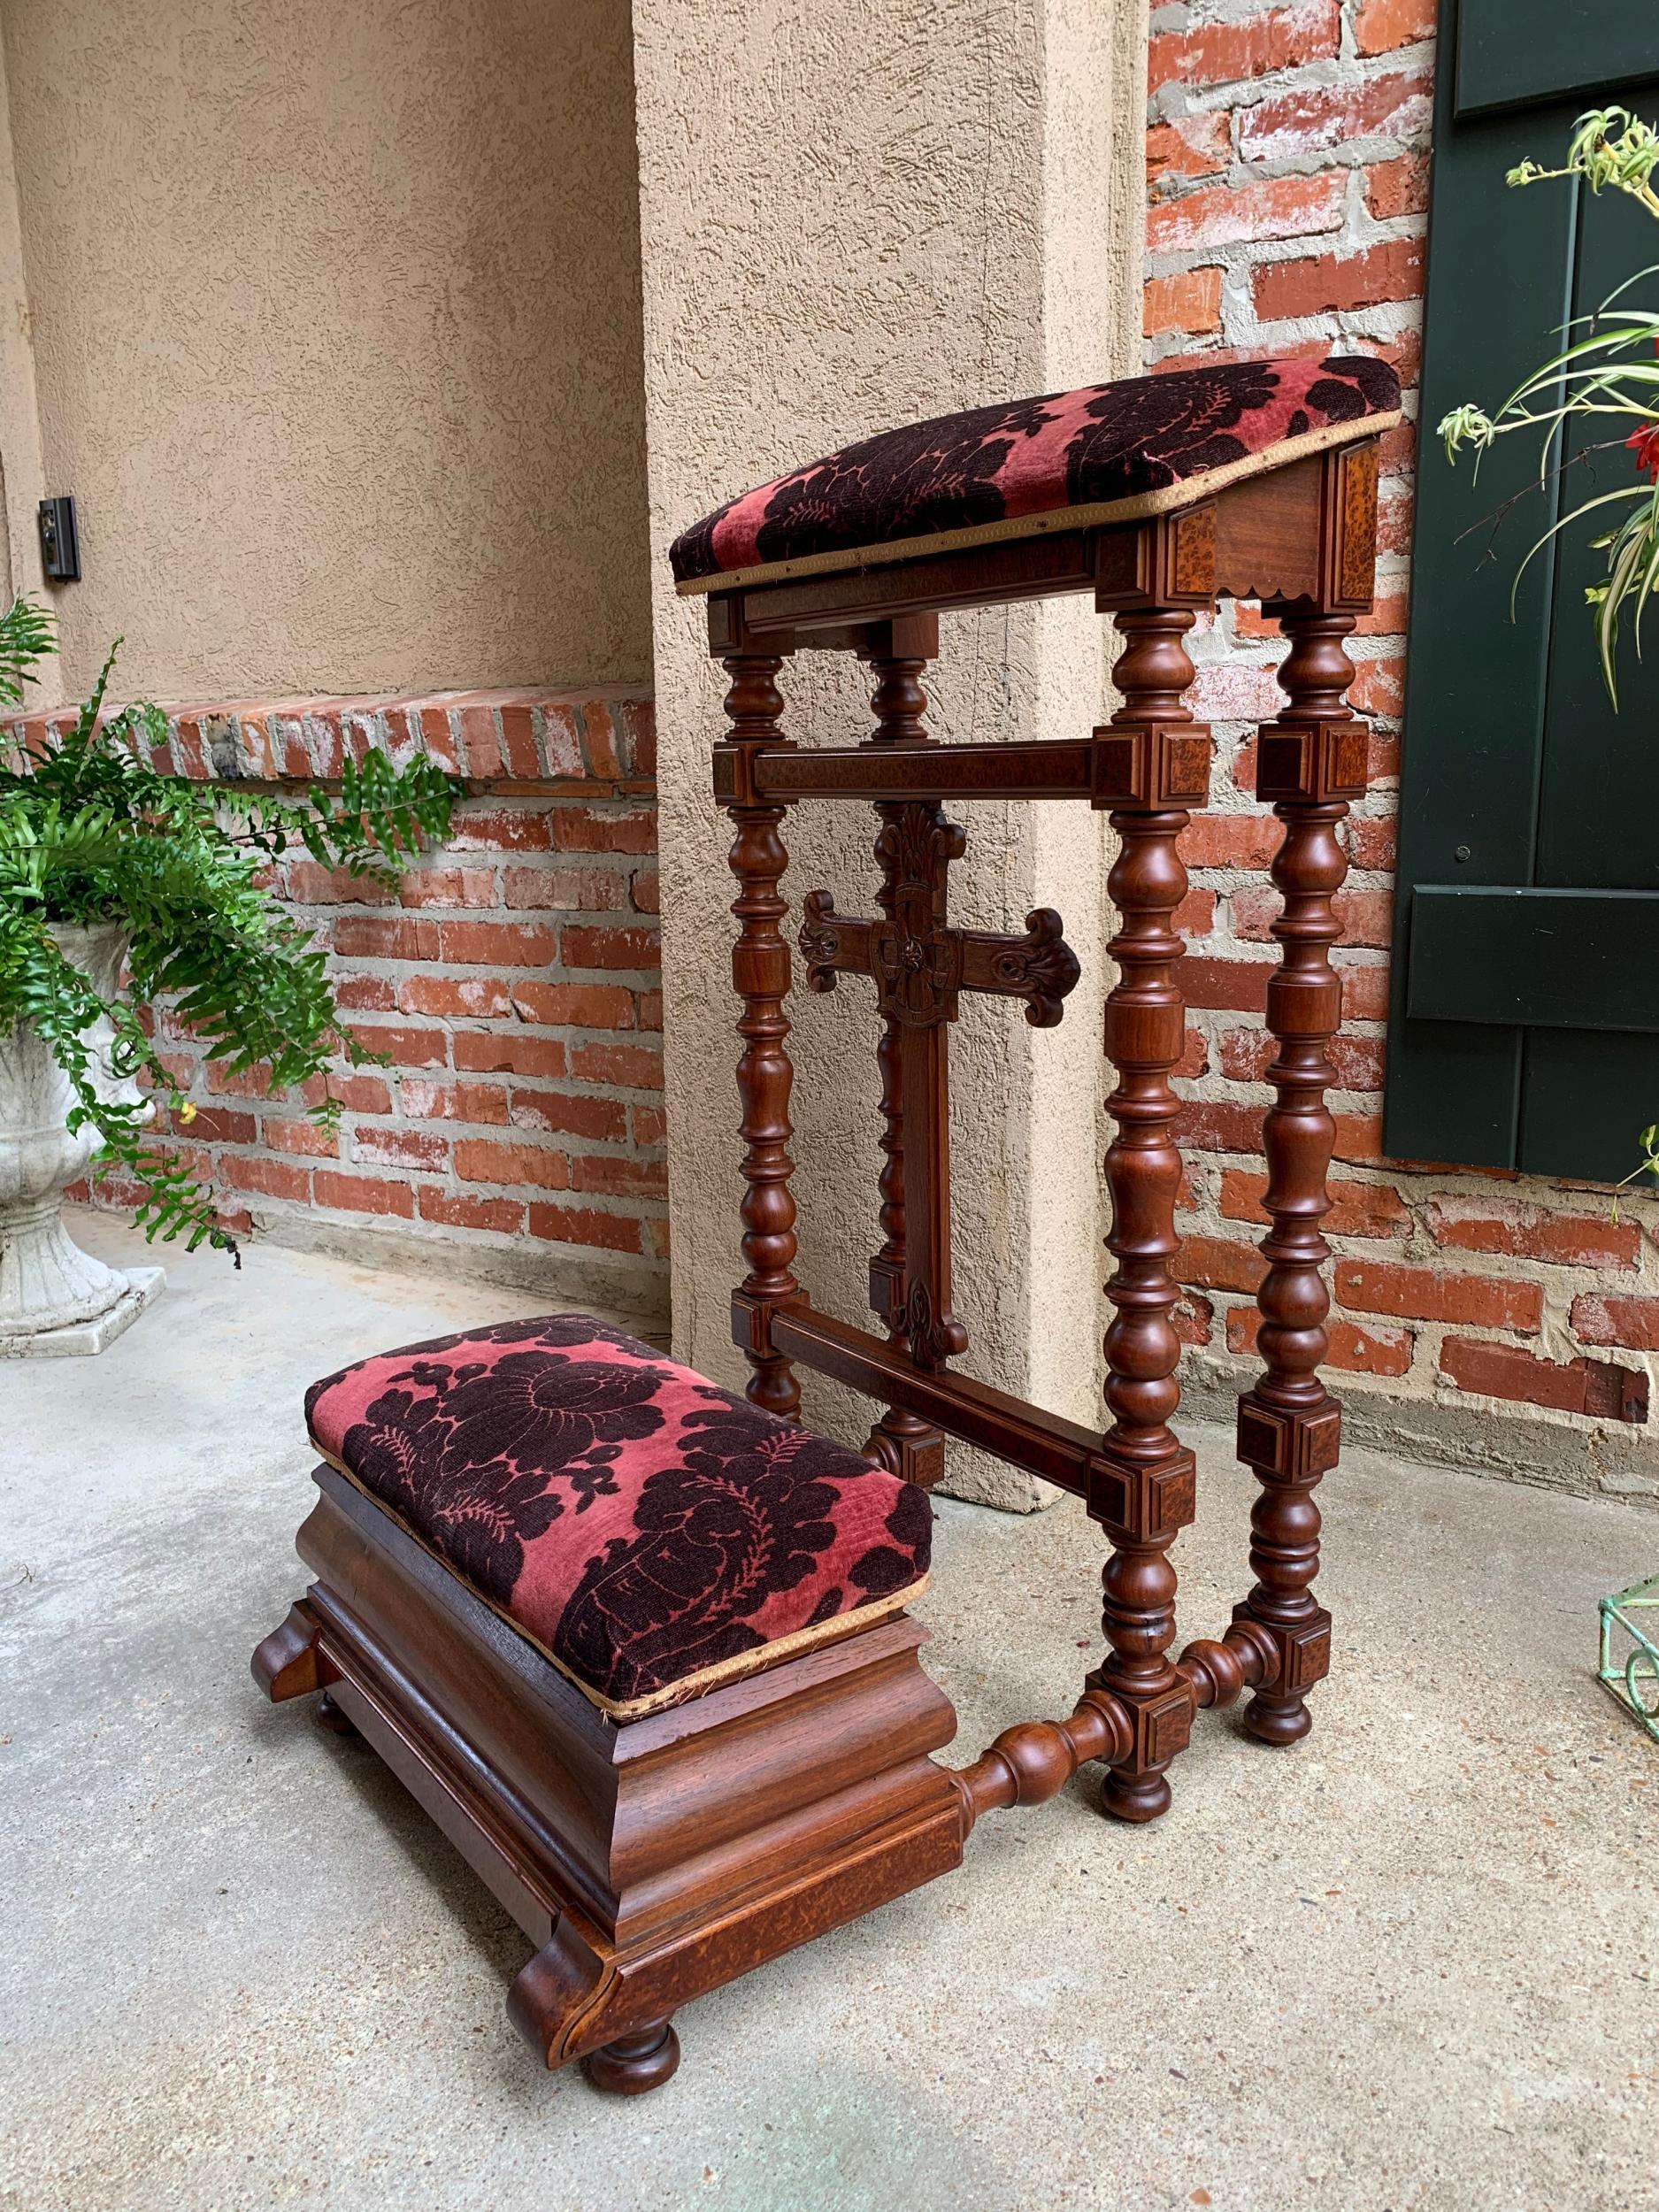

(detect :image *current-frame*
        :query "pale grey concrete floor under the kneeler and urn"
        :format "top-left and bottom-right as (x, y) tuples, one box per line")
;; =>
(0, 1221), (1659, 2212)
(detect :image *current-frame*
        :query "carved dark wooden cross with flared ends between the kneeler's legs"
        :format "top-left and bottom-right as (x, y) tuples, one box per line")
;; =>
(801, 801), (1078, 1367)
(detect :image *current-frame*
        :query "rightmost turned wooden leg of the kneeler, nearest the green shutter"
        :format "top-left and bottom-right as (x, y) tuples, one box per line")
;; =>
(1228, 604), (1367, 1743)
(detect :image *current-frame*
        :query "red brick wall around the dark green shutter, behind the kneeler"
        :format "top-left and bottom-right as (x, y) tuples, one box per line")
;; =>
(1146, 0), (1659, 1495)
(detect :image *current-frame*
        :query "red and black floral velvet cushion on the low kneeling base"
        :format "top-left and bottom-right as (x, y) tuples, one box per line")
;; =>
(305, 1314), (933, 1717)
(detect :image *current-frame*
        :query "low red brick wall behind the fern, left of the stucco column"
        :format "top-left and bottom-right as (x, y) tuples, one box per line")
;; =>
(11, 690), (668, 1310)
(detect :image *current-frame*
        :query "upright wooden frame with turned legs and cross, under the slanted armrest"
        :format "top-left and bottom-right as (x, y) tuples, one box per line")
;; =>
(708, 438), (1379, 1821)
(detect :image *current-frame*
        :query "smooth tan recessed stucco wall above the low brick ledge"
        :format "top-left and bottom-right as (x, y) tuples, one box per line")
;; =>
(0, 0), (650, 699)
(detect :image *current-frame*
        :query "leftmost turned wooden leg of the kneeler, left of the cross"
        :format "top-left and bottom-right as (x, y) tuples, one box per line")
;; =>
(724, 653), (801, 1416)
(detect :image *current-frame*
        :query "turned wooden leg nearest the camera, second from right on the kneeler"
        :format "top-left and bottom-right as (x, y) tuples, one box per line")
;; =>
(1088, 611), (1210, 1821)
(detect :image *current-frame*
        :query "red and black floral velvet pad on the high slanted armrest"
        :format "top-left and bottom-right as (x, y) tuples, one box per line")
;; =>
(668, 354), (1401, 591)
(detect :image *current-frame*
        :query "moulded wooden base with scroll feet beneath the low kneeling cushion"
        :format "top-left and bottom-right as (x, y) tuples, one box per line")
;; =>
(252, 1467), (963, 2095)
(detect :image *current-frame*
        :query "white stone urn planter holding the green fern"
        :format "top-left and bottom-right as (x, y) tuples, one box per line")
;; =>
(0, 923), (166, 1358)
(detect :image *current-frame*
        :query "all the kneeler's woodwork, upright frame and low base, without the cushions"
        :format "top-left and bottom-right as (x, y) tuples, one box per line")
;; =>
(255, 438), (1376, 2093)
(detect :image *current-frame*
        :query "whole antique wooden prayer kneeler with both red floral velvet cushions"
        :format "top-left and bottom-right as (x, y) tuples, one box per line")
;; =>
(255, 358), (1398, 2091)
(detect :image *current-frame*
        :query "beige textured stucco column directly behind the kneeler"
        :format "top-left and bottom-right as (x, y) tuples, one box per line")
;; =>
(633, 0), (1144, 1507)
